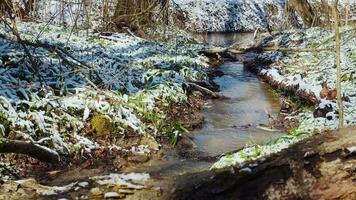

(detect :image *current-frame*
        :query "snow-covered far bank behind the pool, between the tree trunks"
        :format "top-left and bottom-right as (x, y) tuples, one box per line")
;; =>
(173, 0), (356, 32)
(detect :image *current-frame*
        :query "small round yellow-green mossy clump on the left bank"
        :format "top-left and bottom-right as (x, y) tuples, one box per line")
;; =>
(91, 114), (115, 135)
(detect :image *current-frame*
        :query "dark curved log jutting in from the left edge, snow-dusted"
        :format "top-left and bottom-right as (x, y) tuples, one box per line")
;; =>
(0, 138), (60, 163)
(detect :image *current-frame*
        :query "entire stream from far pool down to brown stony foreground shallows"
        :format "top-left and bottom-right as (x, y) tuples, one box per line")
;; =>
(6, 33), (286, 199)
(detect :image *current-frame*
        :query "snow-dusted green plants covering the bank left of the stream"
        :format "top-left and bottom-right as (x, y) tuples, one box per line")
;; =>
(0, 23), (207, 153)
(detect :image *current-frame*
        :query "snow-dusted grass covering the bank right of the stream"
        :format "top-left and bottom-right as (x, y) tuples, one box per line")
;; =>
(212, 28), (356, 169)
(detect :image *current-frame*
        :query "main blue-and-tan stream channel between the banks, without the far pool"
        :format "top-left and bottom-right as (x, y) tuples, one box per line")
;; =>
(193, 62), (283, 156)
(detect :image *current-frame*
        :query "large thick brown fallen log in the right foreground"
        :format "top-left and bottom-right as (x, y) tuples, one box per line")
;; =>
(167, 127), (356, 199)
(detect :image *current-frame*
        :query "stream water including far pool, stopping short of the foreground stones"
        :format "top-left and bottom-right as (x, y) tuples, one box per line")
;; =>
(132, 33), (285, 177)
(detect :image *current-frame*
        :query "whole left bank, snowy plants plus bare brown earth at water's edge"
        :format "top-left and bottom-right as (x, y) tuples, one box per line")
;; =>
(0, 22), (214, 198)
